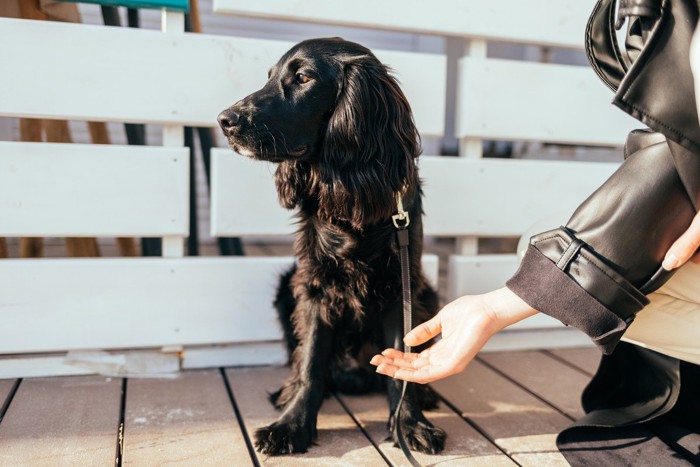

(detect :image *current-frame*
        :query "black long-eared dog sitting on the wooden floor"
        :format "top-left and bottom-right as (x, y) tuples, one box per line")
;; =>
(219, 38), (446, 454)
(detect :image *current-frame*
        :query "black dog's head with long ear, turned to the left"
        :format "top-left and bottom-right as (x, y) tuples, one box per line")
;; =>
(218, 38), (420, 226)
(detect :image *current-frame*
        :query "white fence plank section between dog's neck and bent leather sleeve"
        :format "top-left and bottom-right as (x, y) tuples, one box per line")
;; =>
(420, 156), (618, 237)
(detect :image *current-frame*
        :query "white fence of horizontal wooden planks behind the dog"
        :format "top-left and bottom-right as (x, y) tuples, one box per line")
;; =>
(0, 0), (634, 376)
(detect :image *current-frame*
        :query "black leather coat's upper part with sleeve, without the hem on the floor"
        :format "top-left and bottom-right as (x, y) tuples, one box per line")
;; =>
(507, 0), (700, 354)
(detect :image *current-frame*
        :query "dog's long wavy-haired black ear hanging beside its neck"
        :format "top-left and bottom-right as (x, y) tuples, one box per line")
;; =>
(312, 55), (420, 228)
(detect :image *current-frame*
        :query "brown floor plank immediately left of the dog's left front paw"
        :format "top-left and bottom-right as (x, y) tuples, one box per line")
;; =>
(123, 370), (253, 466)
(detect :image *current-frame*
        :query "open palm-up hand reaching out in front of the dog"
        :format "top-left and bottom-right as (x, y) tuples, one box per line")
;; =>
(370, 288), (537, 383)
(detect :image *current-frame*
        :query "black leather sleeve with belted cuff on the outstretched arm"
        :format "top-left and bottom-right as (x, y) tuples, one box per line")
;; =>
(506, 130), (700, 353)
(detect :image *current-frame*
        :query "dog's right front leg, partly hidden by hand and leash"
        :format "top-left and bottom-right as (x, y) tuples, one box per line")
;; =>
(383, 304), (447, 454)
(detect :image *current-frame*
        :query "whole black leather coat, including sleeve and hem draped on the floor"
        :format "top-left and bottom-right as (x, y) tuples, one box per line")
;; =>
(507, 0), (700, 466)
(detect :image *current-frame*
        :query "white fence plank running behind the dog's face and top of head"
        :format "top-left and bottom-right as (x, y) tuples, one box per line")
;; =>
(0, 18), (446, 135)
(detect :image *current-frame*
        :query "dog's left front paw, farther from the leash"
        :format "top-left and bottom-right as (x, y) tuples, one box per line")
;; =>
(255, 421), (316, 456)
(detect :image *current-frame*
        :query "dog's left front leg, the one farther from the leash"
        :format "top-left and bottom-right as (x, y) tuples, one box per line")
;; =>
(255, 305), (333, 455)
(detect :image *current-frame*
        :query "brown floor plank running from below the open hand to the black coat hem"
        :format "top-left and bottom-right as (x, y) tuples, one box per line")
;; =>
(433, 361), (571, 467)
